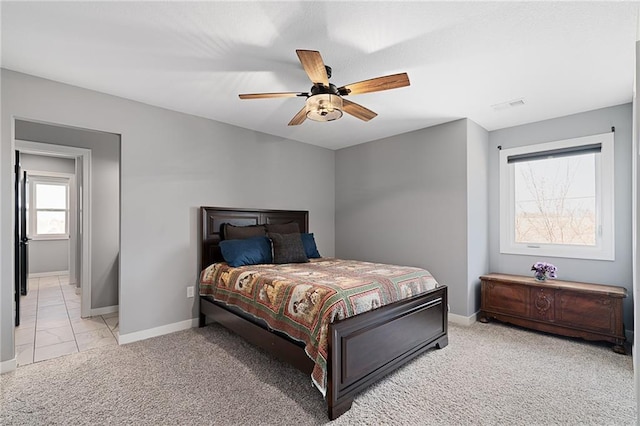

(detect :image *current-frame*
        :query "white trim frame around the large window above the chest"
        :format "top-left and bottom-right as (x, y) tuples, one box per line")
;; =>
(500, 133), (615, 261)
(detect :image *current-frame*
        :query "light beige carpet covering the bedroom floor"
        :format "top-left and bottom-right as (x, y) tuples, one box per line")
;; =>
(0, 322), (636, 425)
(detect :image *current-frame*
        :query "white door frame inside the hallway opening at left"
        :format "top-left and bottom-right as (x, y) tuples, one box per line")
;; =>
(13, 139), (91, 318)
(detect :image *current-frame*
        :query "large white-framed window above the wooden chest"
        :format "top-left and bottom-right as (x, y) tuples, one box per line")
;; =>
(500, 133), (615, 260)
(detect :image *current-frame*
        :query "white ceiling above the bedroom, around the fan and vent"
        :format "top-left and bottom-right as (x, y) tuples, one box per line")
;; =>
(1, 1), (640, 149)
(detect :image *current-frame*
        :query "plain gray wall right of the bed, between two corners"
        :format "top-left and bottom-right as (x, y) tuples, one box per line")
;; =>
(336, 120), (469, 315)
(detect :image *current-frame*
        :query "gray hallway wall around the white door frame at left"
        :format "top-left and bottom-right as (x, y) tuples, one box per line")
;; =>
(15, 120), (120, 309)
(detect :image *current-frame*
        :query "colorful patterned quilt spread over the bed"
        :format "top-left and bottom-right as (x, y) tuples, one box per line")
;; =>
(200, 258), (438, 395)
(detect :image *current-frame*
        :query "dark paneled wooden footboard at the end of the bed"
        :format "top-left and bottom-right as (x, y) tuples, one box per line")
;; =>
(327, 286), (448, 420)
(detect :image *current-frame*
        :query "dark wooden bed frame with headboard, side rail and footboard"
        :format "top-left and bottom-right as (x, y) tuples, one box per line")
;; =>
(200, 207), (448, 420)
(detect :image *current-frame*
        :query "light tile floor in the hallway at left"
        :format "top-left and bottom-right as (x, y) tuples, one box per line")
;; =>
(16, 275), (118, 366)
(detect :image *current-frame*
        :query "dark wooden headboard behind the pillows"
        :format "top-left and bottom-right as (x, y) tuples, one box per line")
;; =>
(200, 207), (309, 270)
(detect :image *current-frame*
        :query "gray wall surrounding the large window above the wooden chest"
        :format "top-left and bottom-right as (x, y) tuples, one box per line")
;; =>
(489, 104), (633, 330)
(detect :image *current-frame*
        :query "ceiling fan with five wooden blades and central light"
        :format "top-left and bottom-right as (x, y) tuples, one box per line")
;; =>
(239, 49), (409, 126)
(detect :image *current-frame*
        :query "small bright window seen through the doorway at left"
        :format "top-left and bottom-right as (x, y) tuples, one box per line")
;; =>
(27, 175), (69, 239)
